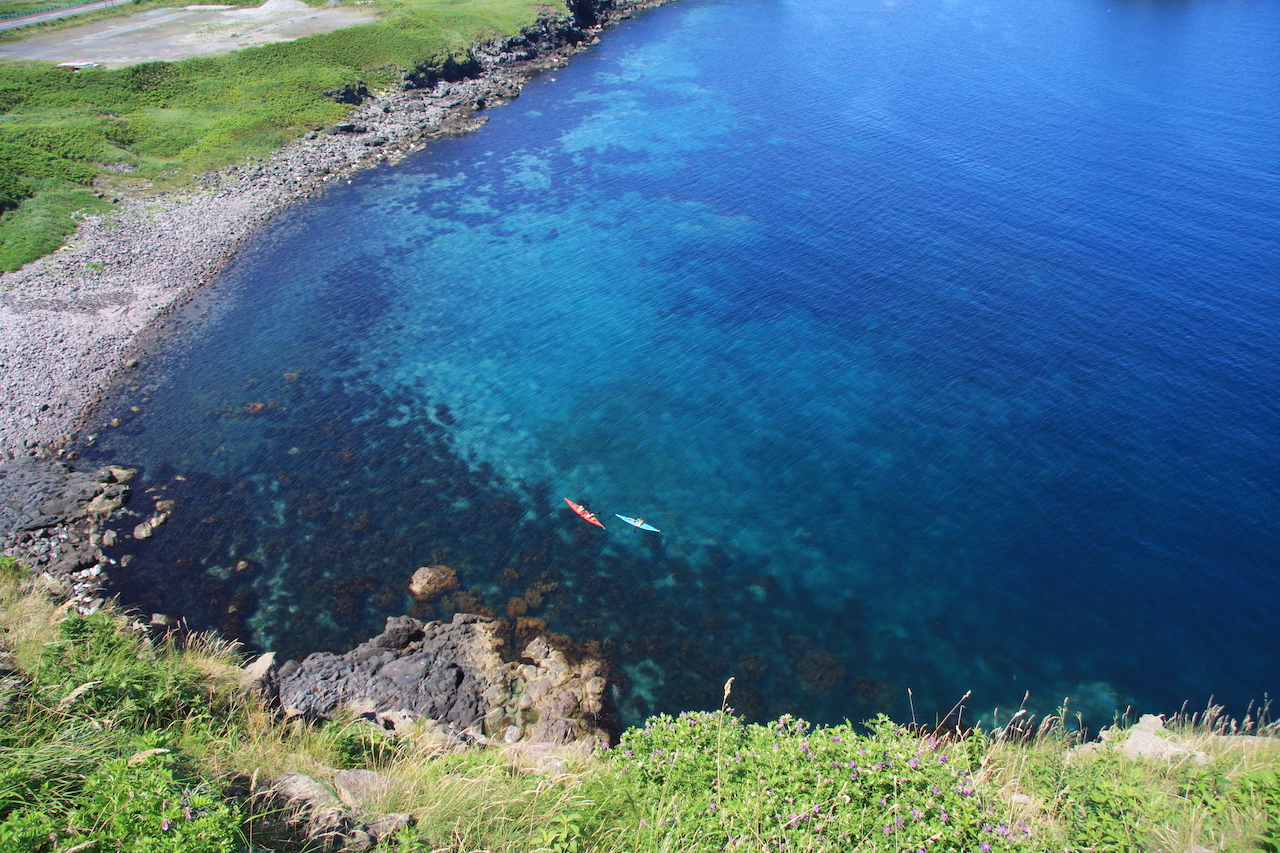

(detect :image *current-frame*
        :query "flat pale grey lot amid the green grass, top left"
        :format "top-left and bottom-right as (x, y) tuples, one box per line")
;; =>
(0, 0), (376, 68)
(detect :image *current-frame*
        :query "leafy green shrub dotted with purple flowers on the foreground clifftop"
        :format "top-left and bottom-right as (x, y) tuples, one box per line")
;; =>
(599, 712), (1033, 852)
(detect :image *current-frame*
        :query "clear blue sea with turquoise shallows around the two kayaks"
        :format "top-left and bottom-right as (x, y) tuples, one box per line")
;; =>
(82, 0), (1280, 729)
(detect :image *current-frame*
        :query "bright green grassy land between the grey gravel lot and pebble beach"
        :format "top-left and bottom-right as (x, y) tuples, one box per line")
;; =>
(0, 0), (545, 270)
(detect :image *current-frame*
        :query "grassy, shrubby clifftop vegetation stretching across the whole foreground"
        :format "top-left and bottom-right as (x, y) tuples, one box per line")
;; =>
(0, 558), (1280, 853)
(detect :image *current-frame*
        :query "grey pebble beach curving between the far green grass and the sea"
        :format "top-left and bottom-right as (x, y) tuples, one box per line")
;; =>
(0, 0), (666, 460)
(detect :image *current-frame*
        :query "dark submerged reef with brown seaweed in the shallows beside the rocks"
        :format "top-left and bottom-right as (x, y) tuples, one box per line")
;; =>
(79, 365), (900, 722)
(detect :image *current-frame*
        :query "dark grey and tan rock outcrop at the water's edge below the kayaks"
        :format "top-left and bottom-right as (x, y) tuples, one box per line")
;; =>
(278, 613), (608, 752)
